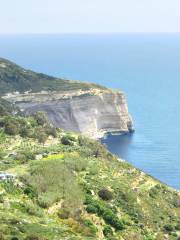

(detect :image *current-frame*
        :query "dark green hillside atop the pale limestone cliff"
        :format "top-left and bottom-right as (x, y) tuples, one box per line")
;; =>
(0, 58), (103, 95)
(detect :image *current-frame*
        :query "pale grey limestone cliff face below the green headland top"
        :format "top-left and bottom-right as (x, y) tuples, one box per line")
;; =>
(4, 89), (133, 138)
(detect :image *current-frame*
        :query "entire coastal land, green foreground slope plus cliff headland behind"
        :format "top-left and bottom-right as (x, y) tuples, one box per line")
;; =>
(0, 59), (180, 240)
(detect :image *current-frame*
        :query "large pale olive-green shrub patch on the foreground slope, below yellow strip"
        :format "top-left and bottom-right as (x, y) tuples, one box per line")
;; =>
(26, 159), (83, 214)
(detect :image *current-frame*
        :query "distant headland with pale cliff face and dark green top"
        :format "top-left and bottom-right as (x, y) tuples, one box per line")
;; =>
(0, 58), (132, 138)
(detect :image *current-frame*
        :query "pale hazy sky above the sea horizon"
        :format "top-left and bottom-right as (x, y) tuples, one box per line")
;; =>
(0, 0), (180, 34)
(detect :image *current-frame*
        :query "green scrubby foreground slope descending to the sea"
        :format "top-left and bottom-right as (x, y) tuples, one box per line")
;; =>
(0, 113), (180, 240)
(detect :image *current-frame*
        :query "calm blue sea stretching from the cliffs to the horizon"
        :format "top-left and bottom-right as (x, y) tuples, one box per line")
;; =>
(0, 34), (180, 189)
